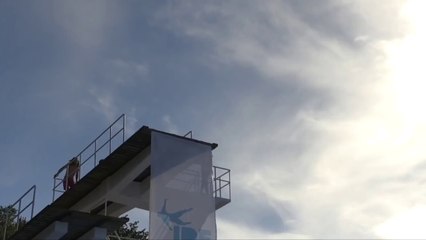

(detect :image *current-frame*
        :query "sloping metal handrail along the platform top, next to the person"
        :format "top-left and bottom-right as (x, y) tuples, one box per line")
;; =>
(52, 114), (126, 202)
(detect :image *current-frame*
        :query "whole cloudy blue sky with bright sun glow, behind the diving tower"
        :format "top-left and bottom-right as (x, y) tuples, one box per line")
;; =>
(0, 0), (426, 239)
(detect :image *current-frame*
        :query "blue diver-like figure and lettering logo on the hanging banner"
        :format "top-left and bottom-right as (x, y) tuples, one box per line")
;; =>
(157, 199), (211, 240)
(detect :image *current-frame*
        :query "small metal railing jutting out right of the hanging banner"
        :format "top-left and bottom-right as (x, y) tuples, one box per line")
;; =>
(213, 166), (231, 200)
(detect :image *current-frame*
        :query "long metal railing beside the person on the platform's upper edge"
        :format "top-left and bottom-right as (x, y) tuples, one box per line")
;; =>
(52, 114), (126, 202)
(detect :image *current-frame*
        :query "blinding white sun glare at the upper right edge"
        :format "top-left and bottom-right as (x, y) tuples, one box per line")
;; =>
(389, 0), (426, 125)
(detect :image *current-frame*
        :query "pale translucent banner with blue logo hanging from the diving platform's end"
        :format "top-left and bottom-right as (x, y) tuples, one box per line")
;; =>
(149, 131), (216, 240)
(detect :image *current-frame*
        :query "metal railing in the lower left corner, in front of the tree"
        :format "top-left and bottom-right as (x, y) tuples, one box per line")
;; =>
(0, 185), (36, 240)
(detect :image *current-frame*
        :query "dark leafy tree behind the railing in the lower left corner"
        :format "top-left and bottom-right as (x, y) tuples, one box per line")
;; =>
(0, 206), (26, 239)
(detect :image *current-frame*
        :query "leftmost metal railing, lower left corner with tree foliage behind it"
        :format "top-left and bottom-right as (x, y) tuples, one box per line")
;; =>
(2, 185), (36, 240)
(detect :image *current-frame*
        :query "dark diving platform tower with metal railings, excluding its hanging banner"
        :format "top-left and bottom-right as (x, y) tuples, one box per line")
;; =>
(0, 114), (231, 240)
